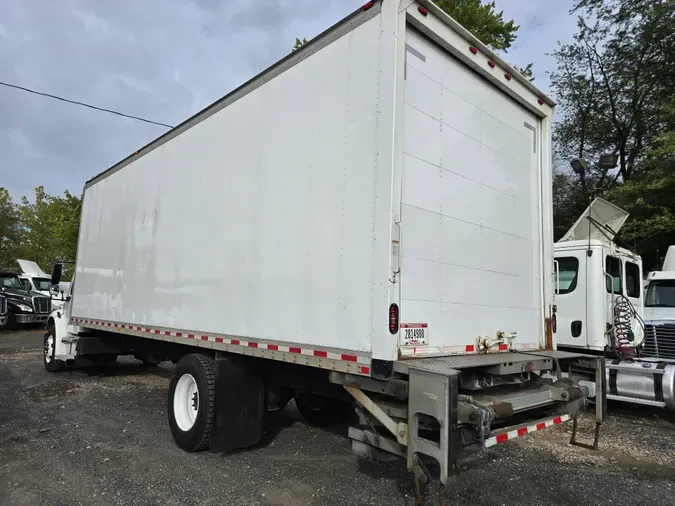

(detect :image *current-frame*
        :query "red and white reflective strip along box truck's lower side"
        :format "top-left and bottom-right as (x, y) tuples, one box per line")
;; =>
(70, 318), (370, 375)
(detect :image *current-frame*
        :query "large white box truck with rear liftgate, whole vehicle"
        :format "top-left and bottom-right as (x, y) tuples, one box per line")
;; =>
(45, 0), (604, 490)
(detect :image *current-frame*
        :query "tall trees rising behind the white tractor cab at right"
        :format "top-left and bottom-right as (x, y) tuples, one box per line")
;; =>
(551, 0), (675, 260)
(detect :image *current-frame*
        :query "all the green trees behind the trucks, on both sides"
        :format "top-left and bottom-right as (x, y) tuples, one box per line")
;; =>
(0, 0), (675, 276)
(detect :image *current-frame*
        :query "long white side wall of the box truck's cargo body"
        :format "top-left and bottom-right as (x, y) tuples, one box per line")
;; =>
(73, 11), (390, 351)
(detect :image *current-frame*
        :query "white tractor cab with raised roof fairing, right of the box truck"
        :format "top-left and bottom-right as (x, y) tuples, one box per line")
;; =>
(554, 198), (644, 354)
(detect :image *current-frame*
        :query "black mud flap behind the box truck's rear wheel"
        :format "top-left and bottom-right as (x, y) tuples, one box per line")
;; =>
(209, 353), (266, 453)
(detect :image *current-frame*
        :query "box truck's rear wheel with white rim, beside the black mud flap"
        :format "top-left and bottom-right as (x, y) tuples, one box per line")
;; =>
(167, 353), (216, 452)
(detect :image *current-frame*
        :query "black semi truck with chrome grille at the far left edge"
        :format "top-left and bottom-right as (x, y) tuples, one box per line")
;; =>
(0, 270), (51, 325)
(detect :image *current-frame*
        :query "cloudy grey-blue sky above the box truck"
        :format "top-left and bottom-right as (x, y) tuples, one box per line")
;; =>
(0, 0), (575, 201)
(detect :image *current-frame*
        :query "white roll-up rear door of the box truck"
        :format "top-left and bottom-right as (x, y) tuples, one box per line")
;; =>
(401, 27), (548, 353)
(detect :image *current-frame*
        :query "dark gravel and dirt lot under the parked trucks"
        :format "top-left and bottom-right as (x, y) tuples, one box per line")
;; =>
(0, 331), (675, 506)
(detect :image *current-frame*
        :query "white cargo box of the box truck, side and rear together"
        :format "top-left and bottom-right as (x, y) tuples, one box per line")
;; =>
(71, 0), (553, 374)
